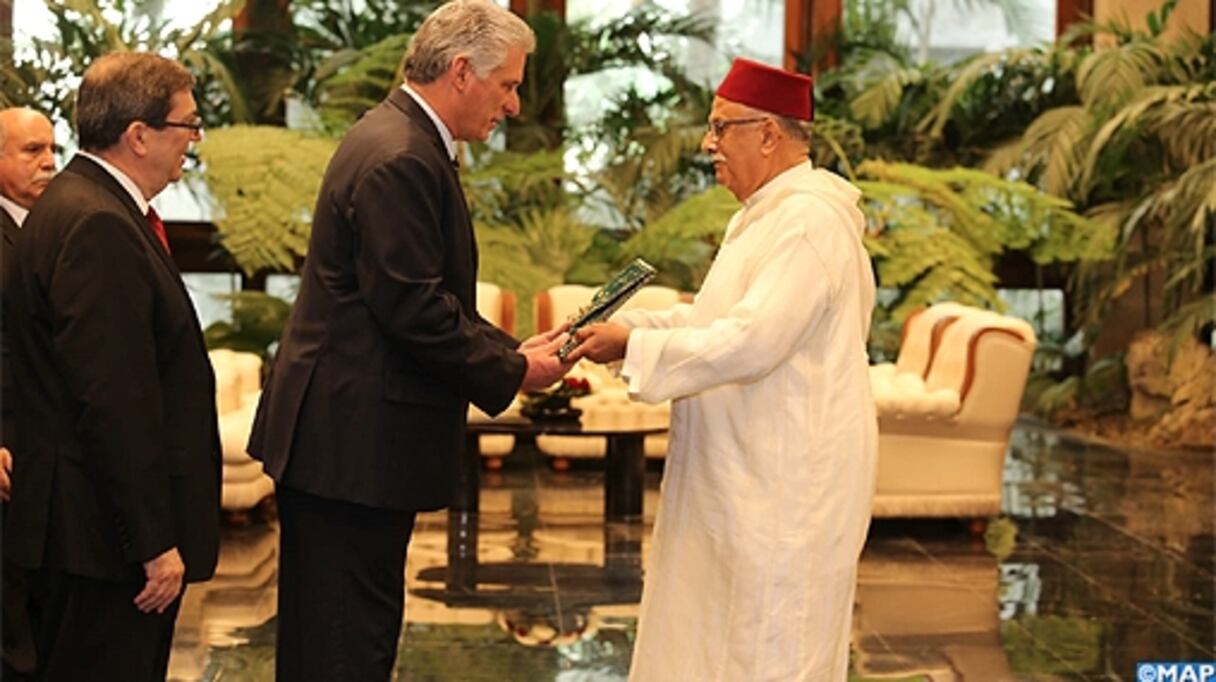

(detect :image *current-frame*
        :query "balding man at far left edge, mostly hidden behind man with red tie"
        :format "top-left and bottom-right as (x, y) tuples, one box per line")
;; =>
(0, 107), (55, 681)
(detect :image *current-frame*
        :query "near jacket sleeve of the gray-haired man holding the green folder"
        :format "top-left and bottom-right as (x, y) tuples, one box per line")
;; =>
(351, 154), (527, 413)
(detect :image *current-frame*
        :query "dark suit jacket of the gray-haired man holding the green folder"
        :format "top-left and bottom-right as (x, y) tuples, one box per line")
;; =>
(249, 90), (527, 511)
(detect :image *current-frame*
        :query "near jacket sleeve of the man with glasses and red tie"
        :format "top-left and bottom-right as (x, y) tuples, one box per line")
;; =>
(47, 213), (175, 562)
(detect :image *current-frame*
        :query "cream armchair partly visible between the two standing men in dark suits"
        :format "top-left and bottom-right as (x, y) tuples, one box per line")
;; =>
(208, 349), (275, 512)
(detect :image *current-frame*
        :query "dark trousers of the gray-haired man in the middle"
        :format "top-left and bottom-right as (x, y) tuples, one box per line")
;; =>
(275, 485), (413, 682)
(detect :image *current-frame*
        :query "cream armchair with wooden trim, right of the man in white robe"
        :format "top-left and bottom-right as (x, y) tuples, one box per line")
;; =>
(871, 304), (1036, 518)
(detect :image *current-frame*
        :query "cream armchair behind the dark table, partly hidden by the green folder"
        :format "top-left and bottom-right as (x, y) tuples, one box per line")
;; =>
(535, 284), (683, 468)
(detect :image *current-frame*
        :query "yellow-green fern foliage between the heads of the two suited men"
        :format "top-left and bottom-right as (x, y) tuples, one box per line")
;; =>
(198, 125), (337, 275)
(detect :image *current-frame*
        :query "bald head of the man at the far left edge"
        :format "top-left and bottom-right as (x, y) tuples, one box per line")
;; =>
(0, 107), (55, 209)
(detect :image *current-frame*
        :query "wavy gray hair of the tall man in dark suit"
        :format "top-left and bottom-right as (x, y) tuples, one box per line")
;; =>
(405, 0), (536, 85)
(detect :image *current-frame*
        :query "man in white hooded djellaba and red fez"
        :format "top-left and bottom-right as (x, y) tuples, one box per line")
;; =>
(572, 60), (877, 682)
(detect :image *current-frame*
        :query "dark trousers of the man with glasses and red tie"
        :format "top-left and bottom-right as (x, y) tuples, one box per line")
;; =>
(29, 569), (181, 682)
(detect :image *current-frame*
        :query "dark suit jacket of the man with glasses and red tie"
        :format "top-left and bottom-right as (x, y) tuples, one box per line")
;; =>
(5, 157), (220, 582)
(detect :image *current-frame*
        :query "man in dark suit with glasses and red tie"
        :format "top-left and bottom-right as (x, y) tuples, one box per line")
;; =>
(5, 52), (220, 682)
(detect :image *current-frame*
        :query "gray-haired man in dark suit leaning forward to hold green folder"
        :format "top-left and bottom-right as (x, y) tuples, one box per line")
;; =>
(249, 0), (568, 682)
